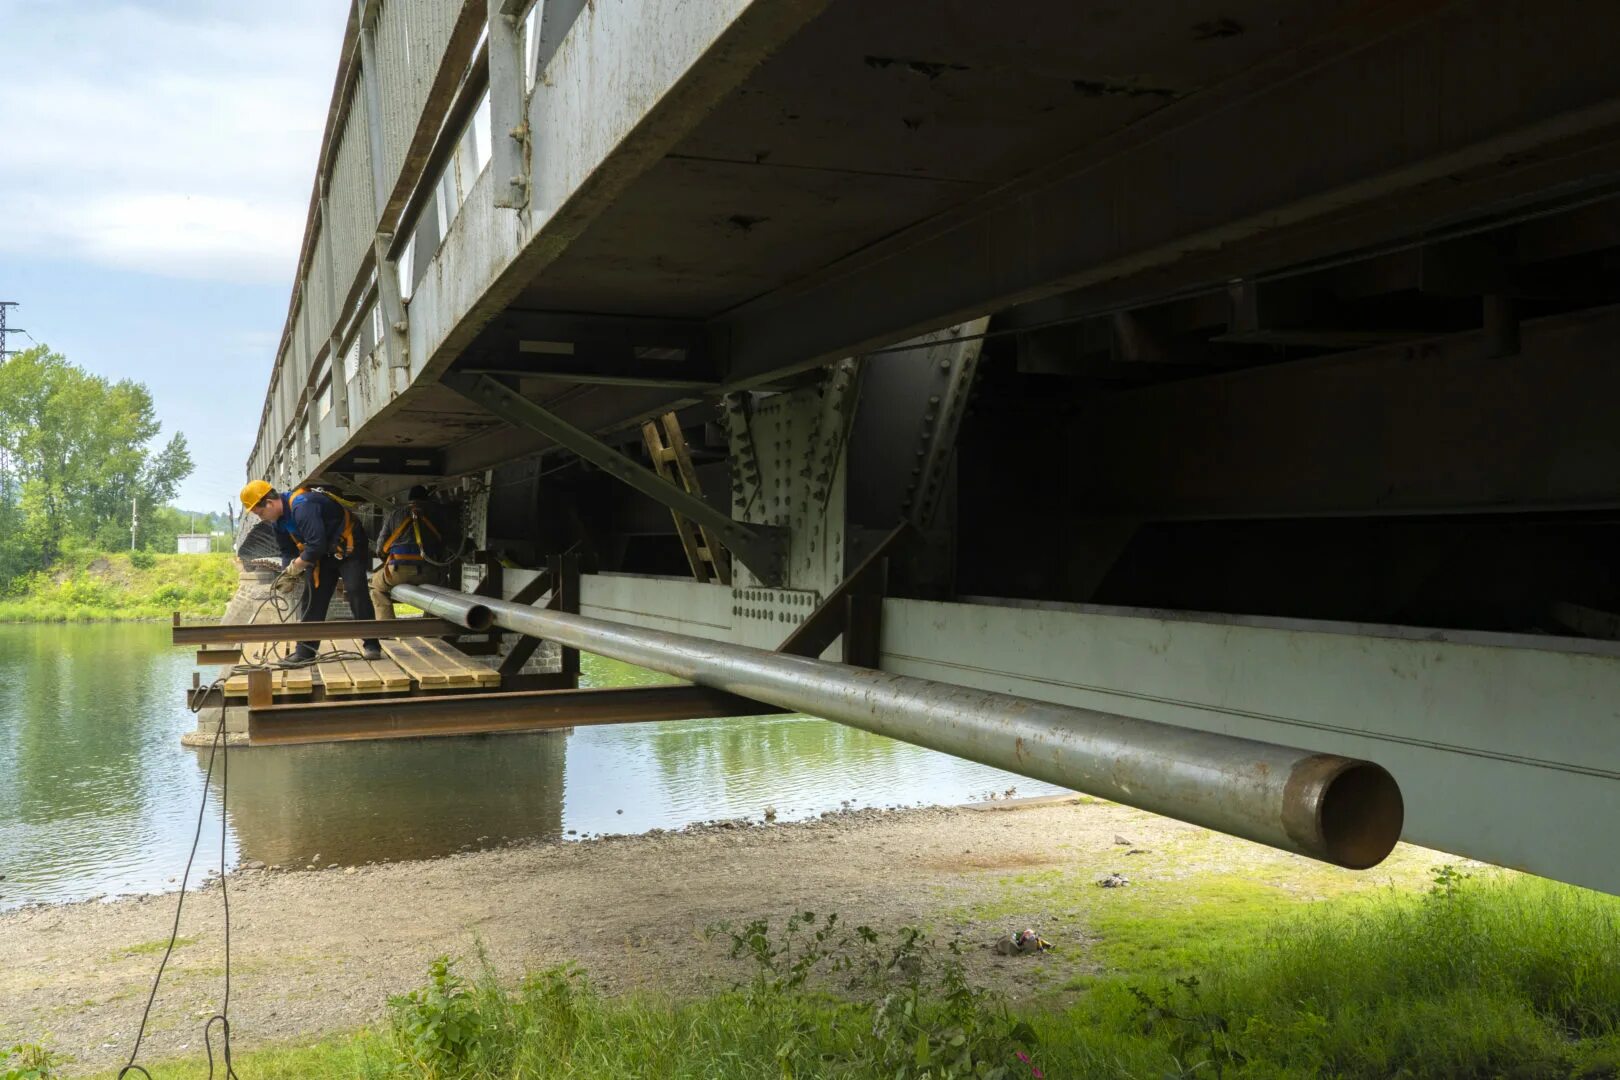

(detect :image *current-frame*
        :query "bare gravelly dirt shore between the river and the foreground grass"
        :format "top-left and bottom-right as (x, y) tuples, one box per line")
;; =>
(0, 800), (1438, 1070)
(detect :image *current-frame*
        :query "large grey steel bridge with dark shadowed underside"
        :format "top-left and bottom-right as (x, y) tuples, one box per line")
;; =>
(246, 0), (1620, 892)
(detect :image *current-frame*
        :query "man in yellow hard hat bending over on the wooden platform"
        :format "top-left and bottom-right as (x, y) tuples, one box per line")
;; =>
(241, 479), (382, 661)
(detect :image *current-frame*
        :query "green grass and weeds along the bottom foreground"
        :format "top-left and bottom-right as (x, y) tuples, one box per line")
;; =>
(69, 868), (1620, 1080)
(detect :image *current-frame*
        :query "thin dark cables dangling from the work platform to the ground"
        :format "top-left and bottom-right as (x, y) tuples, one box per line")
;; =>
(117, 588), (361, 1080)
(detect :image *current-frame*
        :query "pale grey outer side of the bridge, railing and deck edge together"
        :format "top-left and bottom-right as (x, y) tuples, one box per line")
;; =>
(248, 0), (797, 484)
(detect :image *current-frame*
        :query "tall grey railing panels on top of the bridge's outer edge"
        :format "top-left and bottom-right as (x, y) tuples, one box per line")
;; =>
(248, 0), (489, 484)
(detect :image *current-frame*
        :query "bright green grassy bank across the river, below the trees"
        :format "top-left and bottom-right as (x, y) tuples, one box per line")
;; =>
(0, 552), (237, 623)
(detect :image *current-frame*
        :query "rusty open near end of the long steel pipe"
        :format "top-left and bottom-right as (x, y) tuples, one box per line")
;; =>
(1283, 755), (1406, 870)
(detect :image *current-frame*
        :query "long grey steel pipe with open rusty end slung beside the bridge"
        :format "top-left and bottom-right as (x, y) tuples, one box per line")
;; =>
(394, 585), (1403, 870)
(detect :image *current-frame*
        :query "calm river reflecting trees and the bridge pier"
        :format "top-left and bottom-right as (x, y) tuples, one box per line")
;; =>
(0, 623), (1058, 910)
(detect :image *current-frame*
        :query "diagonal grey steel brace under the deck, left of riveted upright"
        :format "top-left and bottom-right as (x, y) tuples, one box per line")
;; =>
(444, 374), (787, 586)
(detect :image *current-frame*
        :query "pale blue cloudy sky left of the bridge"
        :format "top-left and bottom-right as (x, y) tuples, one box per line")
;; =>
(0, 0), (348, 510)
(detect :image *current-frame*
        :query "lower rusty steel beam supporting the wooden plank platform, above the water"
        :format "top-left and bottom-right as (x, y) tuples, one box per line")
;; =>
(248, 687), (786, 746)
